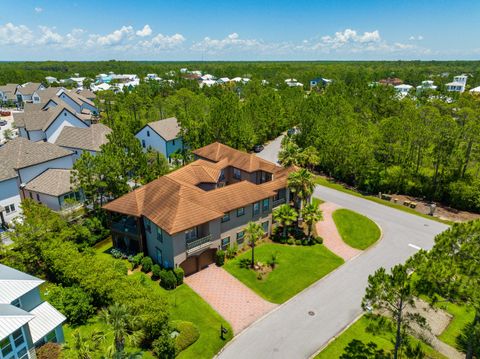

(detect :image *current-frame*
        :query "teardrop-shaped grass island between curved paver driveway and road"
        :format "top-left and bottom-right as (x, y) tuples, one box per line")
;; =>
(332, 208), (380, 250)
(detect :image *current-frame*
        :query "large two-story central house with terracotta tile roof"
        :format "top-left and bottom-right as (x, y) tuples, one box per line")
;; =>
(104, 143), (293, 275)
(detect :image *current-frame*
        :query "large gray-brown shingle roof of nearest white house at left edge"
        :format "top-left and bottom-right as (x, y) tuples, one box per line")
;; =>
(0, 137), (72, 181)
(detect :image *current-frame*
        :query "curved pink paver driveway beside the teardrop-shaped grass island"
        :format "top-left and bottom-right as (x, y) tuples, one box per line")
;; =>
(316, 202), (362, 261)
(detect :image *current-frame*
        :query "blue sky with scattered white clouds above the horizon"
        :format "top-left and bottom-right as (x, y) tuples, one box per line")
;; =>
(0, 0), (480, 61)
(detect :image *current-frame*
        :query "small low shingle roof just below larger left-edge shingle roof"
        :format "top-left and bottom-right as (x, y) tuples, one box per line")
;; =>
(25, 168), (72, 197)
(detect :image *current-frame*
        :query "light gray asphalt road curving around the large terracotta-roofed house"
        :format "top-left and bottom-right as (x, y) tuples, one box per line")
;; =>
(218, 139), (447, 359)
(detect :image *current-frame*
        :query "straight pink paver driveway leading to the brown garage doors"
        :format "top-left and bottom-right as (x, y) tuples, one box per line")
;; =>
(185, 264), (277, 334)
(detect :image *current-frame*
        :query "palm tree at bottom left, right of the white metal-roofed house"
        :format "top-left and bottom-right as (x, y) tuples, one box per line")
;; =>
(100, 303), (143, 358)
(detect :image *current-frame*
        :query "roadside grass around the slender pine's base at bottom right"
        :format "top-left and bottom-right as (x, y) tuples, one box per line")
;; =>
(315, 316), (445, 359)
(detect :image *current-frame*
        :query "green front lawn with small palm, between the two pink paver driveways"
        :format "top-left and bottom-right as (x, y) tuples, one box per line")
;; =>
(224, 243), (343, 303)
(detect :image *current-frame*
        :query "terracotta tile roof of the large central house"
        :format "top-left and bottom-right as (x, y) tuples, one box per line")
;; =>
(104, 145), (284, 234)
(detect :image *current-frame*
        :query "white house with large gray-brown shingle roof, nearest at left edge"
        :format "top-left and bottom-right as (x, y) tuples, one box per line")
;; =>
(0, 137), (73, 223)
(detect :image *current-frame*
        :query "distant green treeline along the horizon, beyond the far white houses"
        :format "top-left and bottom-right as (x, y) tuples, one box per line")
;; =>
(0, 60), (480, 87)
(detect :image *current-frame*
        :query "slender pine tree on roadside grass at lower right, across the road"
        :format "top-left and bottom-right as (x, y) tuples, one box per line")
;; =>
(362, 263), (427, 359)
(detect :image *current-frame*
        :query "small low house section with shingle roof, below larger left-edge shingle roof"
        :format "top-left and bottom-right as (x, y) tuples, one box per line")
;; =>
(23, 168), (85, 211)
